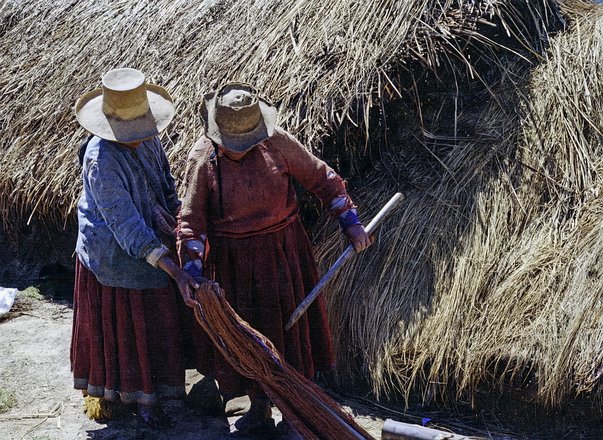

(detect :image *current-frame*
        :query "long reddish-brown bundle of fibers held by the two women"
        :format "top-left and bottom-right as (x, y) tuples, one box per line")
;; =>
(195, 282), (372, 440)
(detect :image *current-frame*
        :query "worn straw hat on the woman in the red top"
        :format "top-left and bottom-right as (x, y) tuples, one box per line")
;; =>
(201, 82), (277, 152)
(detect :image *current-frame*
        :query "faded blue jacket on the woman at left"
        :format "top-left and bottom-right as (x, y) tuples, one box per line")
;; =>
(76, 137), (180, 289)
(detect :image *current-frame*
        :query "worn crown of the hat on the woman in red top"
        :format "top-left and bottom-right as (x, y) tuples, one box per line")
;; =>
(215, 83), (262, 135)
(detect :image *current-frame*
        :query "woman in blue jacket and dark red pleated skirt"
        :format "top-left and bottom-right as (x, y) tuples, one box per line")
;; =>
(71, 68), (205, 427)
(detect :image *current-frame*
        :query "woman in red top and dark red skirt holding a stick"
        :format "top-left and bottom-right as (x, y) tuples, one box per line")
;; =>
(178, 83), (371, 432)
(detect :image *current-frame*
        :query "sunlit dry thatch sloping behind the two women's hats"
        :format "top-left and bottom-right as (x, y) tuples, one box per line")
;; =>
(0, 0), (554, 227)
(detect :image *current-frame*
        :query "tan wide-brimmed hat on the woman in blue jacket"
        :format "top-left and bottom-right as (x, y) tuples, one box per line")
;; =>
(75, 68), (175, 143)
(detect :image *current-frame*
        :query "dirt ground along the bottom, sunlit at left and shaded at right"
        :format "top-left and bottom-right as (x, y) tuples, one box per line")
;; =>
(0, 294), (603, 440)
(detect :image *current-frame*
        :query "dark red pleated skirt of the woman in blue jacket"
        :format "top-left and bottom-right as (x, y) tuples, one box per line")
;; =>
(71, 260), (209, 404)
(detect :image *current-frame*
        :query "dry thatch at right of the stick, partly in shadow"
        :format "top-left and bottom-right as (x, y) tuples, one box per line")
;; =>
(325, 2), (603, 406)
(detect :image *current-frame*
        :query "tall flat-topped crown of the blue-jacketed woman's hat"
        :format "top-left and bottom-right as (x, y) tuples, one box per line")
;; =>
(102, 67), (149, 121)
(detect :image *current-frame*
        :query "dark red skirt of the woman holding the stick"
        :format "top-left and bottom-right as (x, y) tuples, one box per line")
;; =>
(206, 220), (335, 395)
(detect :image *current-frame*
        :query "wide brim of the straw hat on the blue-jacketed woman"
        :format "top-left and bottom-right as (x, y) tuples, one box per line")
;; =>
(75, 84), (176, 142)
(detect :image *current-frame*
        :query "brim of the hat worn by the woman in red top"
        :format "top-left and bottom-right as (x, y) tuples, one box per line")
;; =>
(203, 94), (278, 152)
